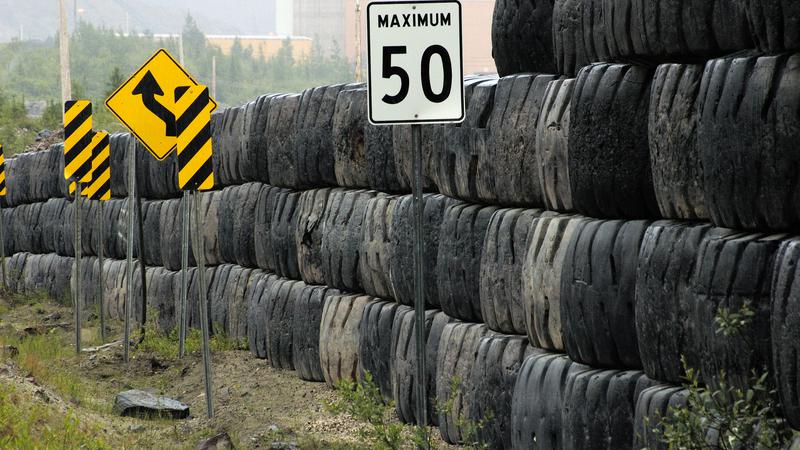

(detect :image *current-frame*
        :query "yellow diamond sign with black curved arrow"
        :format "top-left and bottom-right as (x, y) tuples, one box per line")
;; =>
(106, 48), (217, 161)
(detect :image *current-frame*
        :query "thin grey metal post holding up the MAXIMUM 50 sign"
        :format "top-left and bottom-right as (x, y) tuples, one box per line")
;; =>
(411, 125), (428, 448)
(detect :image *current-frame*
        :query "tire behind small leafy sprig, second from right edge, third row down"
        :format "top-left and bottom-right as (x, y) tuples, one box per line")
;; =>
(685, 233), (788, 388)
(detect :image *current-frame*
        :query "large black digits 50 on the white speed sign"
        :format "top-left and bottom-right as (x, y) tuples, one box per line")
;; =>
(382, 45), (453, 105)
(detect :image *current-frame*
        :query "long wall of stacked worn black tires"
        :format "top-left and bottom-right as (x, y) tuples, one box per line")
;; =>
(2, 0), (800, 449)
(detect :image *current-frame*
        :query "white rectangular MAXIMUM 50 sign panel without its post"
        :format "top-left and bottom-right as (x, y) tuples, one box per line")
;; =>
(367, 0), (464, 125)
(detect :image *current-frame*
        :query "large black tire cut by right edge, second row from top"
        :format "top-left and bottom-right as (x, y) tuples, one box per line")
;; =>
(697, 54), (800, 230)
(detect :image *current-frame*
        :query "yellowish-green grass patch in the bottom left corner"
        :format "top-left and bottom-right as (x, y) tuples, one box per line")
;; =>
(0, 385), (111, 450)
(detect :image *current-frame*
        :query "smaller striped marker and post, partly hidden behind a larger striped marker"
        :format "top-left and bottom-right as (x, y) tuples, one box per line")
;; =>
(83, 131), (111, 343)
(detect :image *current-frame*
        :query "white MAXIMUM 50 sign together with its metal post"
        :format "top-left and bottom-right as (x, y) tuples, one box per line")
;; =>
(367, 0), (465, 442)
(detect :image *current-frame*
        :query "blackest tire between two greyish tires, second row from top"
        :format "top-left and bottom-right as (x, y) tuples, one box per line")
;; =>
(568, 64), (658, 219)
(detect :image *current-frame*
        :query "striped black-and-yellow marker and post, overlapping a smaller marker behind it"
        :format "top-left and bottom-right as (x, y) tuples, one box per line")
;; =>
(64, 100), (94, 354)
